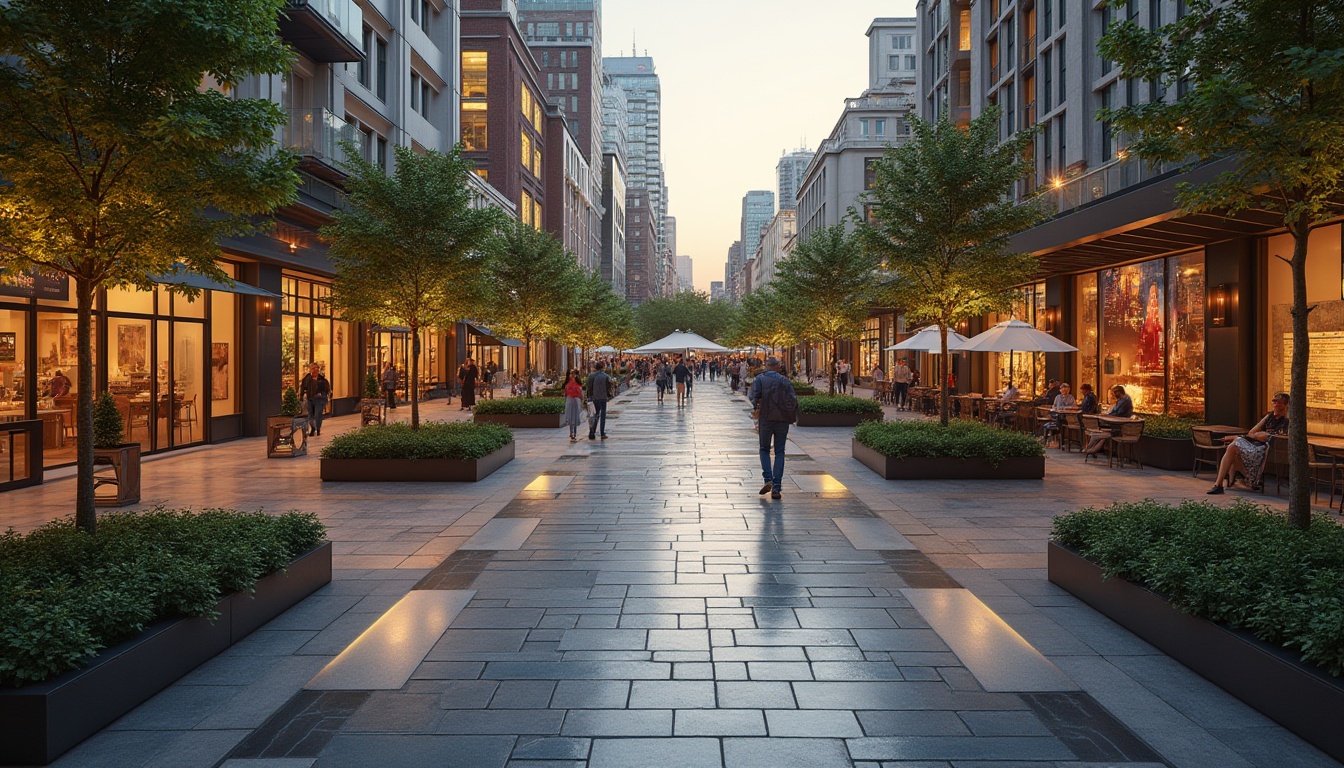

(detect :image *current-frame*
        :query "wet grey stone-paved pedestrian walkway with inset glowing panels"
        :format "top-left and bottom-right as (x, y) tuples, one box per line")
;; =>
(36, 382), (1335, 768)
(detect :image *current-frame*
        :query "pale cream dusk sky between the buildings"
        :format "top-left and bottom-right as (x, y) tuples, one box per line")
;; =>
(602, 0), (915, 291)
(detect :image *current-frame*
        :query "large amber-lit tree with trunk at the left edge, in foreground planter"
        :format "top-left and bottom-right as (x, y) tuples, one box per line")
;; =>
(0, 0), (297, 531)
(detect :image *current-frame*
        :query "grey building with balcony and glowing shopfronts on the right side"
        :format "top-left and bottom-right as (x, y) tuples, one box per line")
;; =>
(918, 0), (1344, 434)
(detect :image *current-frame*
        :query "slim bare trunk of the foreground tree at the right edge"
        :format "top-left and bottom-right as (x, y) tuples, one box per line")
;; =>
(1288, 225), (1312, 530)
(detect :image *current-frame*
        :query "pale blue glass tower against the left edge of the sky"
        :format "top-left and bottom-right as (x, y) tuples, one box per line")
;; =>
(602, 56), (676, 301)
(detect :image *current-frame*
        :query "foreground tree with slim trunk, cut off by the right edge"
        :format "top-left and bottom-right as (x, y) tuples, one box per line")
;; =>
(1098, 0), (1344, 529)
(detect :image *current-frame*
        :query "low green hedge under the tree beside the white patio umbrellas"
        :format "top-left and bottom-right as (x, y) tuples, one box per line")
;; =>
(853, 421), (1046, 467)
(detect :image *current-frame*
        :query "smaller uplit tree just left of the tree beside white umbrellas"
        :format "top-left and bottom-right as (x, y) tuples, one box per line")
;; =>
(771, 223), (882, 394)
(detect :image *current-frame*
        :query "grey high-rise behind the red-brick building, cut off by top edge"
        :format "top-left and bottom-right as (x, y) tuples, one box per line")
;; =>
(517, 0), (602, 168)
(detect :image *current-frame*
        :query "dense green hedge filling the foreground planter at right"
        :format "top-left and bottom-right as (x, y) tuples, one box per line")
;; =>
(1052, 499), (1344, 677)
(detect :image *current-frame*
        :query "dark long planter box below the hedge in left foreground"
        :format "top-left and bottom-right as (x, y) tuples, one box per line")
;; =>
(0, 542), (332, 765)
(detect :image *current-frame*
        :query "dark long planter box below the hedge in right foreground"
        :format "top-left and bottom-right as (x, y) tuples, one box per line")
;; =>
(1047, 542), (1344, 761)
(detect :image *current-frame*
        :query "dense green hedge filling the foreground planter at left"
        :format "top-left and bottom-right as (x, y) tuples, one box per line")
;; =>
(0, 507), (327, 686)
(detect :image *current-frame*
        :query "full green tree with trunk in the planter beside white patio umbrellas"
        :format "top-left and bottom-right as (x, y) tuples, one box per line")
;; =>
(856, 106), (1043, 425)
